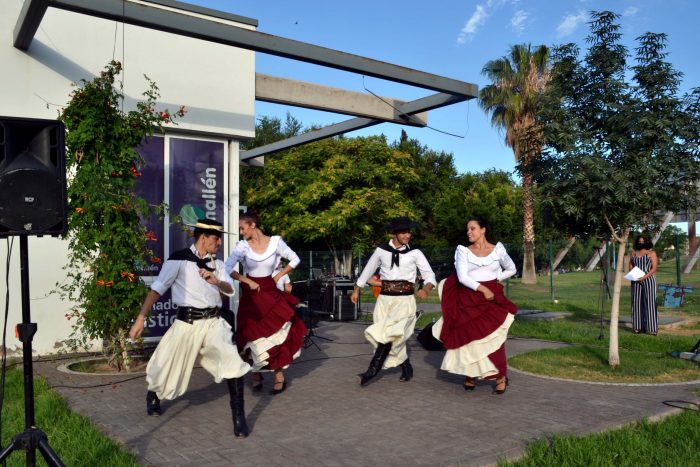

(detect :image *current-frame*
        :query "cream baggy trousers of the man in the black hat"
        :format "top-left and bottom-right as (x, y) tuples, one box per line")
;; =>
(365, 295), (416, 368)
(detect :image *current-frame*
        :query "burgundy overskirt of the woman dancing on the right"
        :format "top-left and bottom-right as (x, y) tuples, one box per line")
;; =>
(440, 273), (518, 349)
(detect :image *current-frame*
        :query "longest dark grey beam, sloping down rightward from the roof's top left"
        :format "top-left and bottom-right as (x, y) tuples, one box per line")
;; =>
(16, 0), (478, 99)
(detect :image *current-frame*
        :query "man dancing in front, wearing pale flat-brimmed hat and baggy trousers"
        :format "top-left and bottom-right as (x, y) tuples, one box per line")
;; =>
(129, 219), (250, 437)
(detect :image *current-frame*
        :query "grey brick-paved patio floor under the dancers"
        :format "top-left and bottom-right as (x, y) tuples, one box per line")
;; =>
(34, 321), (700, 466)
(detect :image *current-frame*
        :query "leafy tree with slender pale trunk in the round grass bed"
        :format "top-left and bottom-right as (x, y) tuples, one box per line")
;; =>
(528, 11), (700, 367)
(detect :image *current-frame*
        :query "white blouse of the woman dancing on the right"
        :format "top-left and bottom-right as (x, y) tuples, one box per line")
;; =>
(455, 242), (516, 290)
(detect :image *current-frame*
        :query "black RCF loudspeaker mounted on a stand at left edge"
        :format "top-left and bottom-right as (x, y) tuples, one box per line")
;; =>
(0, 117), (68, 236)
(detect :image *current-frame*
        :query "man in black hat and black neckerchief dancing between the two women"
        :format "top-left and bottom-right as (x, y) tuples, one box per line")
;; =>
(350, 217), (437, 385)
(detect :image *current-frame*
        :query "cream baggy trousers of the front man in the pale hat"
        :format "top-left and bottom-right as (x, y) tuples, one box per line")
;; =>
(146, 318), (250, 399)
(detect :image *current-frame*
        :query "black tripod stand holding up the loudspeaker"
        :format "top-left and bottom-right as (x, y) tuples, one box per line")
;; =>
(0, 235), (65, 467)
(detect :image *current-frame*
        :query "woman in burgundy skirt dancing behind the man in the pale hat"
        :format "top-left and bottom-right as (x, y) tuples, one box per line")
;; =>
(226, 212), (306, 394)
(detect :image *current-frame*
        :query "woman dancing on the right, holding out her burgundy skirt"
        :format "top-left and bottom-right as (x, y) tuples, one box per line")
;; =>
(433, 218), (517, 394)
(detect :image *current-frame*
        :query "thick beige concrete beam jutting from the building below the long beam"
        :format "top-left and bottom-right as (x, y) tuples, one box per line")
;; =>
(255, 73), (428, 127)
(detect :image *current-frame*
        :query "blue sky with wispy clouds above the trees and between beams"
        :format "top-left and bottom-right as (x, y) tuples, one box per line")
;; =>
(189, 0), (700, 176)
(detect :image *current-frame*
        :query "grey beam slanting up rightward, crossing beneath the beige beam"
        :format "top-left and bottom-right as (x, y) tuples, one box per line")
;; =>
(240, 93), (467, 163)
